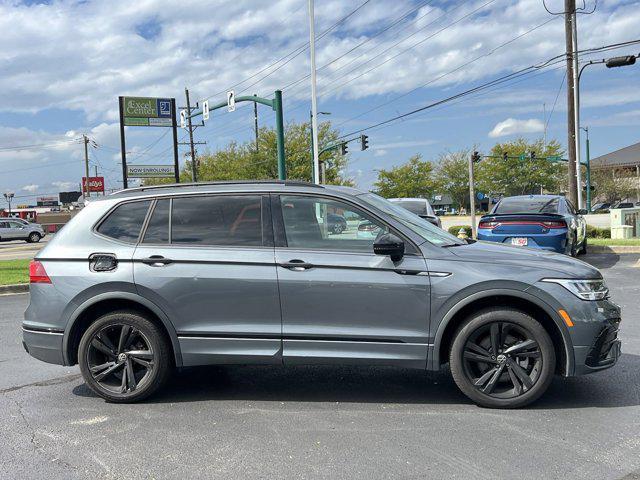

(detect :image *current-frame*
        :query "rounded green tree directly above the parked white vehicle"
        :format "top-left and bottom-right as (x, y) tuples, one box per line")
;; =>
(374, 154), (436, 198)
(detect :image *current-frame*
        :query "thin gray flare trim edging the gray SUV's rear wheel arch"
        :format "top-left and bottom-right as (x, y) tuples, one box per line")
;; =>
(62, 291), (182, 367)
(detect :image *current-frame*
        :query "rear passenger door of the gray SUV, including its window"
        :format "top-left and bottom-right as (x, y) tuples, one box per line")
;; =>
(134, 194), (281, 365)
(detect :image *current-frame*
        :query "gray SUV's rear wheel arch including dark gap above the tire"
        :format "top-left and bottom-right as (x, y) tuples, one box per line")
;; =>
(62, 292), (182, 367)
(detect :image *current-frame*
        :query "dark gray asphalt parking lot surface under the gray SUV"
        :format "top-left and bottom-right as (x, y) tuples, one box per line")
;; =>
(0, 254), (640, 480)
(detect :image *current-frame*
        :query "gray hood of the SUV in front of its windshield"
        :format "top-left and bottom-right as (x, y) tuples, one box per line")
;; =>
(449, 241), (602, 278)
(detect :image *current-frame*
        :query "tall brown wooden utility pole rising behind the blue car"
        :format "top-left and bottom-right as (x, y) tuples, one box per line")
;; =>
(564, 0), (578, 205)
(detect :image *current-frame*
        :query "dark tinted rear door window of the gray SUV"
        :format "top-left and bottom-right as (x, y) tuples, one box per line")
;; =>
(171, 195), (262, 246)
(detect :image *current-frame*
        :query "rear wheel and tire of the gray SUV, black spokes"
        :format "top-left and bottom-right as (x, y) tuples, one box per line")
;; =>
(78, 310), (172, 403)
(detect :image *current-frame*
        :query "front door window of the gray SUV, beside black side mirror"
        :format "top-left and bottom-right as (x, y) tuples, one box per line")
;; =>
(280, 195), (388, 253)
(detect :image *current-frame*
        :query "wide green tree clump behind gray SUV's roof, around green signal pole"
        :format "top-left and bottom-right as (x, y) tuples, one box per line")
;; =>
(145, 122), (353, 185)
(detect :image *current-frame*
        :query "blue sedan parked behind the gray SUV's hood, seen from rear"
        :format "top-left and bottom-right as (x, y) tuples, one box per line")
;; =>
(478, 195), (587, 257)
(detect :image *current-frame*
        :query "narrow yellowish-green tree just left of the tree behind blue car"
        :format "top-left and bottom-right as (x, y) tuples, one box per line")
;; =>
(436, 150), (471, 207)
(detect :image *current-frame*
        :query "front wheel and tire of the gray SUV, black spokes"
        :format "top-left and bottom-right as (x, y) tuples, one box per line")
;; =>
(449, 307), (556, 408)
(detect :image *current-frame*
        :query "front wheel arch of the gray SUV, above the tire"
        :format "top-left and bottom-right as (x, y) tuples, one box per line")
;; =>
(428, 289), (574, 376)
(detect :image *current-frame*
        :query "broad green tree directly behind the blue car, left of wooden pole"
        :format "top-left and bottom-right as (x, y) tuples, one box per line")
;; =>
(476, 138), (567, 196)
